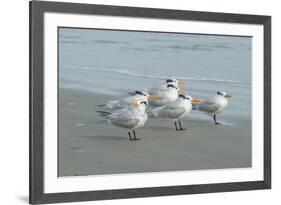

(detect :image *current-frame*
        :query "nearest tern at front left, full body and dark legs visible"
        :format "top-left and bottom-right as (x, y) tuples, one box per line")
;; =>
(97, 100), (147, 140)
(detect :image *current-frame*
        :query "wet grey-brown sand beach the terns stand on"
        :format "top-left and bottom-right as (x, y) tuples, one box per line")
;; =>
(58, 88), (251, 176)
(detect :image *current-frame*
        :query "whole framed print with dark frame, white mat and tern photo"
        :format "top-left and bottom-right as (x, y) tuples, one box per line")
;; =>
(30, 1), (271, 204)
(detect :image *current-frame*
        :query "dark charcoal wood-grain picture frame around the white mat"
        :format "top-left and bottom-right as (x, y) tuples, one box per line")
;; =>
(29, 1), (271, 204)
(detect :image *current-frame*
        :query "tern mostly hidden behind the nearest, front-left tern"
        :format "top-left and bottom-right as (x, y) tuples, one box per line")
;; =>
(98, 91), (157, 111)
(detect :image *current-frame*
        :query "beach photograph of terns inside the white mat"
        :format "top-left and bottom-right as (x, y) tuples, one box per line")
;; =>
(57, 27), (252, 177)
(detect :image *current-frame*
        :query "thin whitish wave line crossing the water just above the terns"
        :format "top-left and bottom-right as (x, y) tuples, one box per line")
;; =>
(60, 66), (250, 85)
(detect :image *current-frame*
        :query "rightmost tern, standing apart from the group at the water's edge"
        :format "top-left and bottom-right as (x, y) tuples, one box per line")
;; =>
(193, 91), (231, 125)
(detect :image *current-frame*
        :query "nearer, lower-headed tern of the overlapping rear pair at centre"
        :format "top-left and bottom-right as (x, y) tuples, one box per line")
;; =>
(148, 83), (186, 107)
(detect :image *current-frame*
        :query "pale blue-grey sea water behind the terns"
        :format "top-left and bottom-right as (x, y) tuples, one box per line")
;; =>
(59, 28), (252, 125)
